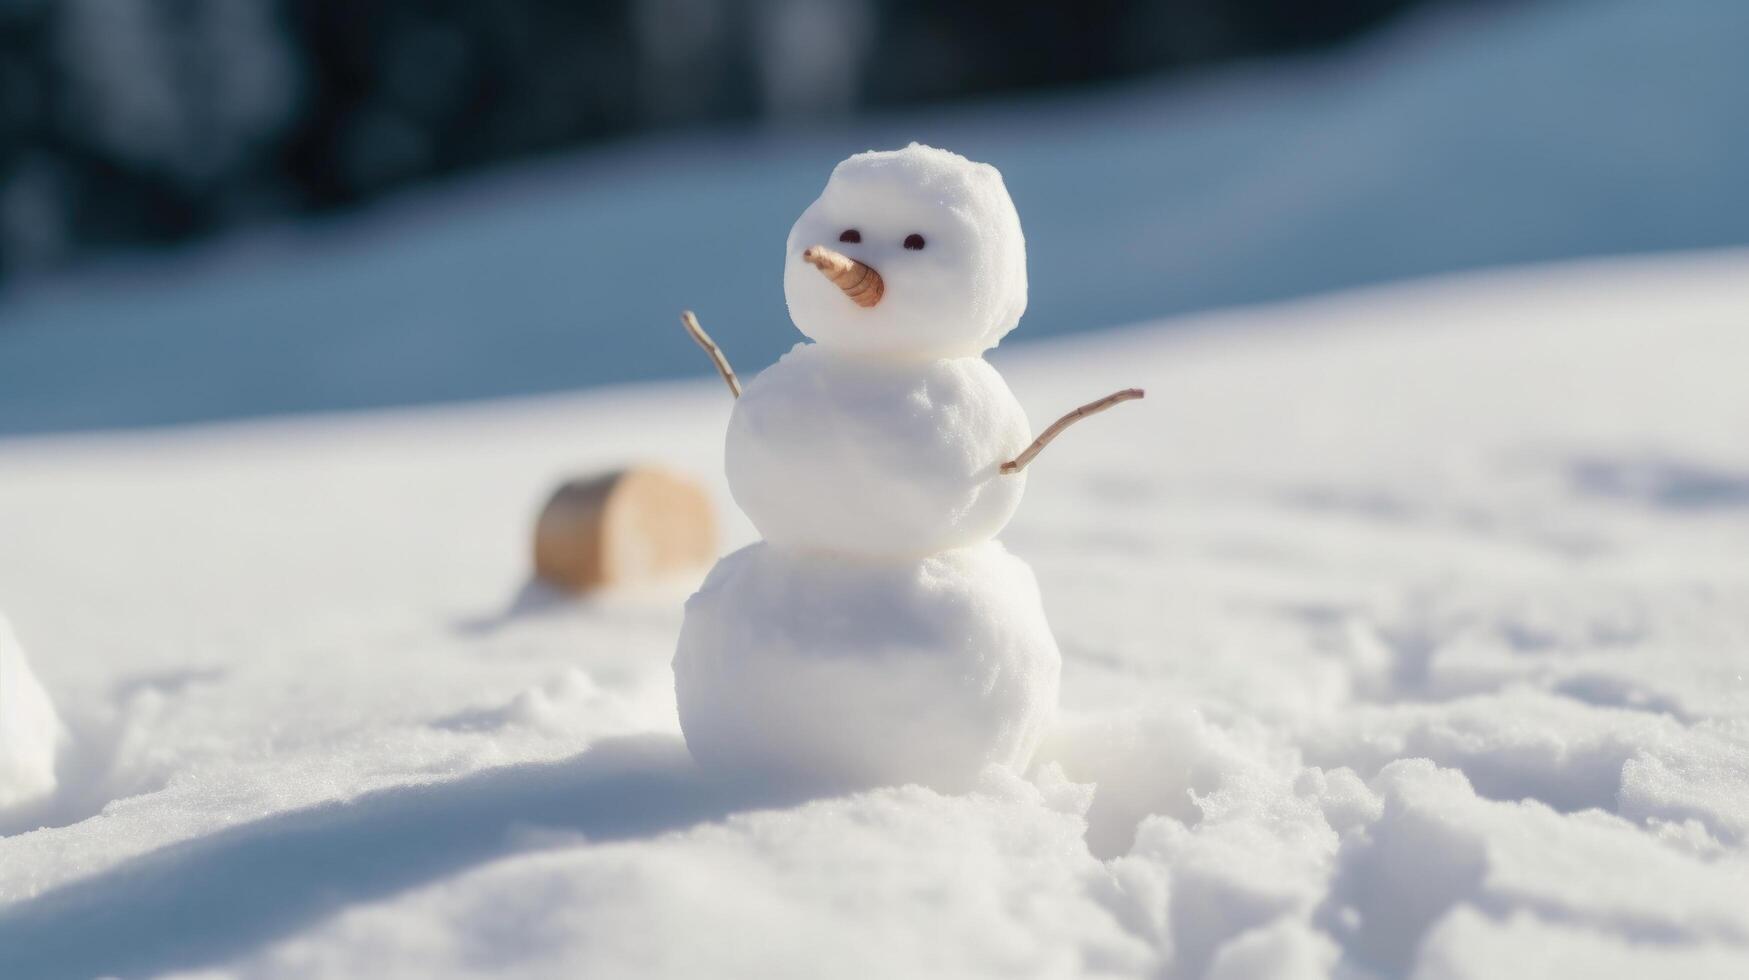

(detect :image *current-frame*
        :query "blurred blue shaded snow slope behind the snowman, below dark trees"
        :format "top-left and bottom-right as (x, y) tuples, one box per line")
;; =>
(0, 0), (1749, 432)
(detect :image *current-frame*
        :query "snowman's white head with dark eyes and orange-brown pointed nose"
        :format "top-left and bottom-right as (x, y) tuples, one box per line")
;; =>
(784, 144), (1027, 357)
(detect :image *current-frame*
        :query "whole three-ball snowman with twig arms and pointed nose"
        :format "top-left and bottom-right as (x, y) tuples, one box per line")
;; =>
(673, 144), (1142, 791)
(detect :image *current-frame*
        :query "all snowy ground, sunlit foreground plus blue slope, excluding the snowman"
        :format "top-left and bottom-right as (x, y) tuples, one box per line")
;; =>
(0, 0), (1749, 980)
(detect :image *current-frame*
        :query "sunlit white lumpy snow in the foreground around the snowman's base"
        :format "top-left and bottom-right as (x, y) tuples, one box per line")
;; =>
(0, 252), (1749, 980)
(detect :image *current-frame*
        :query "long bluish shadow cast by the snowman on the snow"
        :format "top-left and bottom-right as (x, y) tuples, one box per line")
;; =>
(0, 735), (812, 978)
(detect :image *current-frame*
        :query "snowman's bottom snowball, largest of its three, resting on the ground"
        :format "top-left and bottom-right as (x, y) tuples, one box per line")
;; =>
(673, 543), (1062, 791)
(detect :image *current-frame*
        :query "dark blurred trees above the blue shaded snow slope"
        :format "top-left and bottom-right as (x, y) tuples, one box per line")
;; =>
(0, 0), (1441, 277)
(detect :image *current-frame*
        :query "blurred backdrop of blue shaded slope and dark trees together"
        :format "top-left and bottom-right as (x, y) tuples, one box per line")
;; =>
(0, 0), (1749, 434)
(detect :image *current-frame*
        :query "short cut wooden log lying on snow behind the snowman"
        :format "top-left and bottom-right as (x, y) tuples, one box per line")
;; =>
(535, 466), (717, 592)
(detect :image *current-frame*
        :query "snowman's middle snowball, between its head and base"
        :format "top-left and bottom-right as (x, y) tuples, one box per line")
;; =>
(728, 345), (1030, 558)
